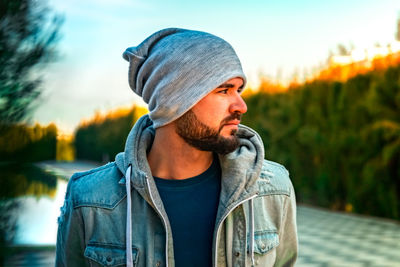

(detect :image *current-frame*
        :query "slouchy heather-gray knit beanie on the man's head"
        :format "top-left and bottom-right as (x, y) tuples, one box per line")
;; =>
(123, 28), (246, 128)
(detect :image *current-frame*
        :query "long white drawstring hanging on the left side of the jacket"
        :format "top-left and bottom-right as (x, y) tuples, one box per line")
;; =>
(125, 165), (133, 267)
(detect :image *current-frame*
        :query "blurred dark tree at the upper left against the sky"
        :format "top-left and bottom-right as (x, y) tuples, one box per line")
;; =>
(0, 0), (63, 126)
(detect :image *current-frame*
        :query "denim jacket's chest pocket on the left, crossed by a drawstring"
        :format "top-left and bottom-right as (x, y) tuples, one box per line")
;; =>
(84, 243), (139, 266)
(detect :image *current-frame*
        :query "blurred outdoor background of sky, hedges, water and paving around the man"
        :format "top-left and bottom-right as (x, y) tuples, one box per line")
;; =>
(0, 0), (400, 266)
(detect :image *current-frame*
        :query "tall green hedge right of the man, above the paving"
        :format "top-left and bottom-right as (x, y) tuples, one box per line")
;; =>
(243, 65), (400, 219)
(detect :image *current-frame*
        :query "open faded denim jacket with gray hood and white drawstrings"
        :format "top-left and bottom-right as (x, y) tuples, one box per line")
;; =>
(56, 115), (298, 267)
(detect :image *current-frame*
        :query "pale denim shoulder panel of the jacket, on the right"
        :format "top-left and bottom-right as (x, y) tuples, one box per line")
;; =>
(257, 160), (294, 196)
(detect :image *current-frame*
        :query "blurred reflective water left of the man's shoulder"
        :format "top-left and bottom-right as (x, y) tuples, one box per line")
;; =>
(0, 162), (96, 246)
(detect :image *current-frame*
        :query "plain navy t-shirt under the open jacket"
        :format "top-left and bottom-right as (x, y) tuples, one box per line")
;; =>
(154, 157), (221, 267)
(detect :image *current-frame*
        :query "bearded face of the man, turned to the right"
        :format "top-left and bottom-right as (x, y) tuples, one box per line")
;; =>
(176, 78), (247, 154)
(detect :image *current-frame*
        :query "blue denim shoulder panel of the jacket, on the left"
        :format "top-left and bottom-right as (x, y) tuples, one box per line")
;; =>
(68, 162), (126, 209)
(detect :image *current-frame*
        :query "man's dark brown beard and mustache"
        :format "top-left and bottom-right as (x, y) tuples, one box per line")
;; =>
(176, 110), (242, 155)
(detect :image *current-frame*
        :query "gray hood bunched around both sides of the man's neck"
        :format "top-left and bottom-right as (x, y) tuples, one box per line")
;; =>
(115, 115), (264, 205)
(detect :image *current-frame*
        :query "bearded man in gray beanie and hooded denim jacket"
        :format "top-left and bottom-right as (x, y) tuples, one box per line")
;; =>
(56, 28), (297, 267)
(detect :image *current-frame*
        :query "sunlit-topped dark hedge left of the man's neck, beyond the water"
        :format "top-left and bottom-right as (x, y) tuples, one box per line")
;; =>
(75, 107), (146, 162)
